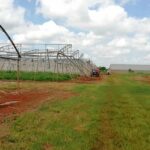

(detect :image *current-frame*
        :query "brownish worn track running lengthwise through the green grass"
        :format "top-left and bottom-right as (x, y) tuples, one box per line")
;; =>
(92, 78), (118, 150)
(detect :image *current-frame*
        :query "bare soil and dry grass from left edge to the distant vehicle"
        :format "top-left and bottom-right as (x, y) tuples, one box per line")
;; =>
(0, 75), (106, 122)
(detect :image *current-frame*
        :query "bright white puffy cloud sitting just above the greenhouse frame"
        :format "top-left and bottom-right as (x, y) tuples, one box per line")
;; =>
(14, 21), (69, 43)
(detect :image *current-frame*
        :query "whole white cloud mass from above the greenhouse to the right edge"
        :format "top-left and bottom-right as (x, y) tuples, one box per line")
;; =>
(15, 0), (150, 65)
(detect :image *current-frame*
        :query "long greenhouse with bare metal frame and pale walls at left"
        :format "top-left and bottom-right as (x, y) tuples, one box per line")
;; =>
(0, 26), (94, 79)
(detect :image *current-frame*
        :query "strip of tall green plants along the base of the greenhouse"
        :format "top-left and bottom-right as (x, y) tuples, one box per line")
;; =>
(0, 71), (77, 81)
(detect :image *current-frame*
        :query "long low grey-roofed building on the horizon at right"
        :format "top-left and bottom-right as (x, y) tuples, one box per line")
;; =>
(109, 64), (150, 72)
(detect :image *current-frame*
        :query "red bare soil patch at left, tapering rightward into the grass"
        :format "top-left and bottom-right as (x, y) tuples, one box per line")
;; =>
(0, 89), (73, 122)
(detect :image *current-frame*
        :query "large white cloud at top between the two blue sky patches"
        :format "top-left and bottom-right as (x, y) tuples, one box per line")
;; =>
(34, 0), (137, 34)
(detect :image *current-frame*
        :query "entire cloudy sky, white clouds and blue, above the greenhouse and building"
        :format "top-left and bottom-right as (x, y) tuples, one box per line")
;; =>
(0, 0), (150, 66)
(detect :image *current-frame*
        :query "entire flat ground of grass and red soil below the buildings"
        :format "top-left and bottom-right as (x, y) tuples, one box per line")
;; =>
(0, 73), (150, 150)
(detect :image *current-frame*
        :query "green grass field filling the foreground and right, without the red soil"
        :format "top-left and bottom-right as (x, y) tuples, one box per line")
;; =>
(0, 73), (150, 150)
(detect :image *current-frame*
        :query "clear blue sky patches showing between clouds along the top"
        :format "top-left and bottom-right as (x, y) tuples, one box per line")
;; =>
(15, 0), (150, 24)
